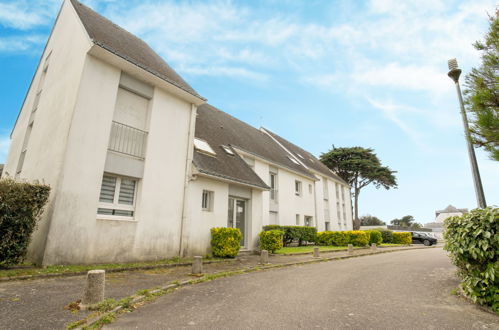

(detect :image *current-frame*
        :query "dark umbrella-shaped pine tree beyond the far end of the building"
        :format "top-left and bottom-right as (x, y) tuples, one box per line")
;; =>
(320, 146), (397, 227)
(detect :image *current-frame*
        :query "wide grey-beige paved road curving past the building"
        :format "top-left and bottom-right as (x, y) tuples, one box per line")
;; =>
(106, 248), (499, 330)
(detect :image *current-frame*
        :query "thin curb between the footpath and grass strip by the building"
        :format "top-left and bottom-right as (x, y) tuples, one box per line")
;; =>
(0, 258), (238, 282)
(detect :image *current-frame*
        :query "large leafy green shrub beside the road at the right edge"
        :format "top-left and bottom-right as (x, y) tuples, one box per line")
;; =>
(444, 207), (499, 313)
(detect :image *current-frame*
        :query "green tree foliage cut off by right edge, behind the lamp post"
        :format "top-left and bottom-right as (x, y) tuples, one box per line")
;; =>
(464, 9), (499, 161)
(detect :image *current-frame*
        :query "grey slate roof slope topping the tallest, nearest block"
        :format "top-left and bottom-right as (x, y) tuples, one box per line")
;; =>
(71, 0), (203, 99)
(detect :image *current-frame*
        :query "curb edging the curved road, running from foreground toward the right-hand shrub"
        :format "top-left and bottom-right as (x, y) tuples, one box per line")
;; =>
(74, 245), (438, 330)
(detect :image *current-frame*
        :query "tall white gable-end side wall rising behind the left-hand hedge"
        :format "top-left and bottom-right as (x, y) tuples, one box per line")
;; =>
(3, 2), (91, 262)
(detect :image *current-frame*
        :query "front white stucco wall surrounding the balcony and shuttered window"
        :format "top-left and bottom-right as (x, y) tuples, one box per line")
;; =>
(44, 55), (192, 264)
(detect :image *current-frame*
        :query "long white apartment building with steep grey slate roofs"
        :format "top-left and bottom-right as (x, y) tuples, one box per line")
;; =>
(3, 0), (352, 265)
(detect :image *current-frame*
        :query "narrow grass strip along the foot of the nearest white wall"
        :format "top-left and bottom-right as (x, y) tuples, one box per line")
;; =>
(0, 257), (219, 278)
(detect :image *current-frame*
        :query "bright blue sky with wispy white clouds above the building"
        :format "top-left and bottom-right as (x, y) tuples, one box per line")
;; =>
(0, 0), (499, 223)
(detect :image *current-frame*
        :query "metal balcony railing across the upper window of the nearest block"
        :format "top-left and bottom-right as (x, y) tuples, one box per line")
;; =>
(108, 121), (147, 159)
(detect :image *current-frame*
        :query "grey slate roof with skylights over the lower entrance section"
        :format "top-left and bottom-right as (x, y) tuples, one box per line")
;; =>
(194, 104), (316, 188)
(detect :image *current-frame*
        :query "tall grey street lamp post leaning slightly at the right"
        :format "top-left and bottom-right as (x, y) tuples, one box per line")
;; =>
(447, 58), (487, 209)
